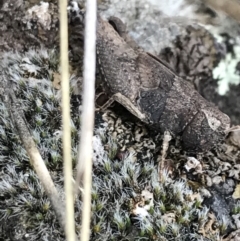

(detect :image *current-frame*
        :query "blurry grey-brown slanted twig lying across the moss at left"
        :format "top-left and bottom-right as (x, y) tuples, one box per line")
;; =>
(2, 81), (65, 232)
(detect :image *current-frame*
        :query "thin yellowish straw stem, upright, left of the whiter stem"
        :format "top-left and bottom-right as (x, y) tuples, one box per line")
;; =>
(59, 0), (75, 241)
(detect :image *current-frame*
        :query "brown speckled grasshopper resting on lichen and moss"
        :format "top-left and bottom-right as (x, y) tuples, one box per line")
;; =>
(96, 17), (230, 153)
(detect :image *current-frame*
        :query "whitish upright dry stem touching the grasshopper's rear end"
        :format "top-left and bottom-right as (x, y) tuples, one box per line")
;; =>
(76, 0), (97, 241)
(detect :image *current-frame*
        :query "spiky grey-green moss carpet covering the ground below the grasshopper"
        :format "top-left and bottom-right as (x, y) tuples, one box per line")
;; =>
(0, 50), (232, 240)
